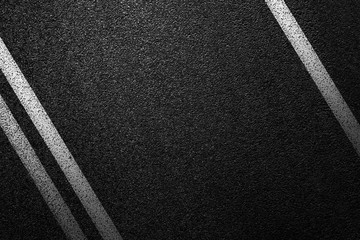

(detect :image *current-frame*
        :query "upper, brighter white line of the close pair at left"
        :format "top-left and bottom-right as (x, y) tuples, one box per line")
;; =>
(0, 38), (122, 240)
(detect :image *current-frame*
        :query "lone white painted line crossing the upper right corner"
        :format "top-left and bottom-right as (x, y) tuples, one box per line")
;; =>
(265, 0), (360, 157)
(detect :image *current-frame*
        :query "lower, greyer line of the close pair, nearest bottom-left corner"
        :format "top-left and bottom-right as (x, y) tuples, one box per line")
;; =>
(0, 95), (86, 240)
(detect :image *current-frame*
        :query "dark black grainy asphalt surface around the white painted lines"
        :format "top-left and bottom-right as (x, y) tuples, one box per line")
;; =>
(0, 0), (360, 240)
